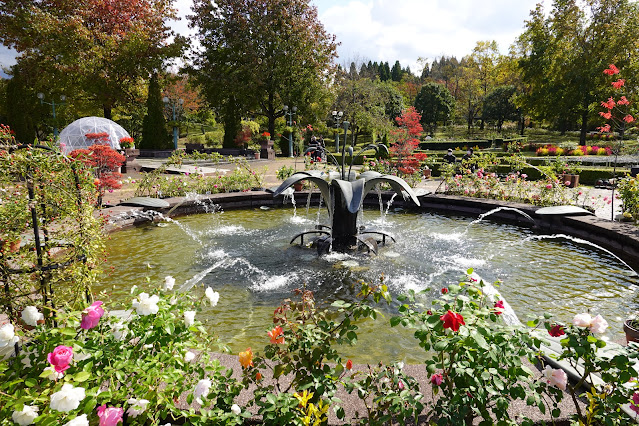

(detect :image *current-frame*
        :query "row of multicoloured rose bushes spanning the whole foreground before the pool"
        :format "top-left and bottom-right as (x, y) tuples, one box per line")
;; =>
(0, 270), (639, 426)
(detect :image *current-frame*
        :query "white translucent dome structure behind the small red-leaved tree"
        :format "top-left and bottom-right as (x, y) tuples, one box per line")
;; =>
(58, 117), (129, 154)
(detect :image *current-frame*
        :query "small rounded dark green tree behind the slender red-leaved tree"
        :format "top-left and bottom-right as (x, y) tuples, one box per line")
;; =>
(415, 83), (455, 136)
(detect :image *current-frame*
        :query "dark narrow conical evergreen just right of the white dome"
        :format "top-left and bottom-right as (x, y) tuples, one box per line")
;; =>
(140, 74), (173, 149)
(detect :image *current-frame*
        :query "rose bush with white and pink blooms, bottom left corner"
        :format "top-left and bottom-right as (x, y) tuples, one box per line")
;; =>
(0, 277), (248, 426)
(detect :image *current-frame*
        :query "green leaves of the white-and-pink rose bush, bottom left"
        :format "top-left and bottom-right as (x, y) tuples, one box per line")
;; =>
(0, 282), (243, 425)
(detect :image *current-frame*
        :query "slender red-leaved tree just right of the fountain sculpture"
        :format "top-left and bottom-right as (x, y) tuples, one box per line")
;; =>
(390, 107), (424, 174)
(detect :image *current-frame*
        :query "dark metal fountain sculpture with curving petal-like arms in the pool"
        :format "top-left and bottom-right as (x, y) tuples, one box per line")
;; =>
(273, 121), (419, 254)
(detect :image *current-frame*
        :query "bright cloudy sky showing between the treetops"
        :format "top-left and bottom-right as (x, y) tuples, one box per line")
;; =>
(0, 0), (550, 76)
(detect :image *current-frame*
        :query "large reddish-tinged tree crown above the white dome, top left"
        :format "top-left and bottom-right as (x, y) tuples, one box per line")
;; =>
(0, 0), (185, 118)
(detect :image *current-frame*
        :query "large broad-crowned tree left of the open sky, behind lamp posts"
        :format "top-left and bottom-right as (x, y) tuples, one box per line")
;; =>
(189, 0), (337, 142)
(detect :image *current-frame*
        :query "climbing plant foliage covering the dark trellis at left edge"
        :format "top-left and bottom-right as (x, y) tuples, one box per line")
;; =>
(0, 141), (104, 321)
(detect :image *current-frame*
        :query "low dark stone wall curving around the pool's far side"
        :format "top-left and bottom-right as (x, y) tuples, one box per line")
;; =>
(101, 191), (639, 265)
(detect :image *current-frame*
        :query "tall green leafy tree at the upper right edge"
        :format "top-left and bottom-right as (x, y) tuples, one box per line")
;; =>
(518, 0), (639, 143)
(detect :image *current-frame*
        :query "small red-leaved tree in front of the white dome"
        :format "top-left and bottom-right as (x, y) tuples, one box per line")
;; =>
(69, 143), (126, 206)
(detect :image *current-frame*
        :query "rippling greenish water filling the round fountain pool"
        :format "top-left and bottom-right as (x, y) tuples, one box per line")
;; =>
(102, 208), (639, 362)
